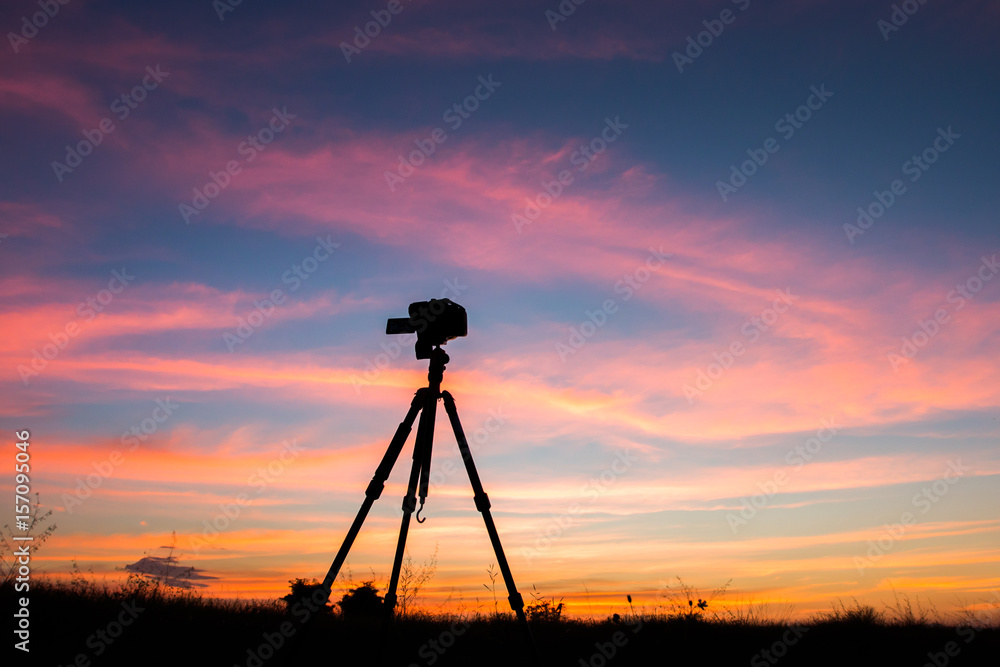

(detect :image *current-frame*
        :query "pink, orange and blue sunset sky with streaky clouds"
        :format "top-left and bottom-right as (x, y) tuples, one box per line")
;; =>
(0, 0), (1000, 614)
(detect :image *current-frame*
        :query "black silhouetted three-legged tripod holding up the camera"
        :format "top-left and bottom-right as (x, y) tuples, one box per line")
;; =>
(322, 346), (540, 665)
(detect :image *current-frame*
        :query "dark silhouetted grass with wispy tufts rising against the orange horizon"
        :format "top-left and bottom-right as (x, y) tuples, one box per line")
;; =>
(0, 573), (1000, 667)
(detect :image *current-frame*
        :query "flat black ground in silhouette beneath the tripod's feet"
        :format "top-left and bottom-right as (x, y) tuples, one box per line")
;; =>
(0, 584), (1000, 667)
